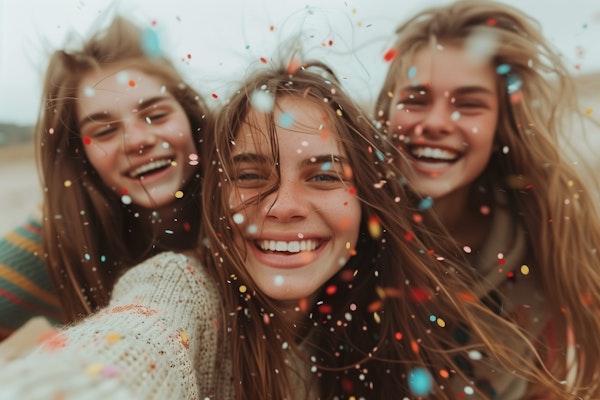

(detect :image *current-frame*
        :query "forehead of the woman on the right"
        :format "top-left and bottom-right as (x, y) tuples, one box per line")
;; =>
(397, 45), (497, 93)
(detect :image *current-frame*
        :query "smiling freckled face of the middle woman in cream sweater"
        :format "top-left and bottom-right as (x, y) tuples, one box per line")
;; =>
(230, 97), (361, 301)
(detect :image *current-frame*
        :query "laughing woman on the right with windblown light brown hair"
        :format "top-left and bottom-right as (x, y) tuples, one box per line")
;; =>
(376, 0), (600, 399)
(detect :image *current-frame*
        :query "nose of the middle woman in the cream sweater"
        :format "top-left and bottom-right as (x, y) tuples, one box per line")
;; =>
(263, 179), (309, 222)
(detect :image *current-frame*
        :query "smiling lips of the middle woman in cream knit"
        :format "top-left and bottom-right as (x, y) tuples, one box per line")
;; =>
(246, 237), (330, 269)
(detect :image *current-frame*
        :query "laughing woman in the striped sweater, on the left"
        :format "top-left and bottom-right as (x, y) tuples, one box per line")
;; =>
(0, 17), (210, 336)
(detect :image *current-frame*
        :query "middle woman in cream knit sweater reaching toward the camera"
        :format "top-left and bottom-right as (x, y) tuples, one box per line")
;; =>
(0, 62), (454, 399)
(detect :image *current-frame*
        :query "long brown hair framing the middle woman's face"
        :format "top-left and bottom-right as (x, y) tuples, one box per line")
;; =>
(201, 58), (472, 399)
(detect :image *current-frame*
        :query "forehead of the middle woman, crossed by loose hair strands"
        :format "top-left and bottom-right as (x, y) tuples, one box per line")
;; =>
(234, 96), (343, 154)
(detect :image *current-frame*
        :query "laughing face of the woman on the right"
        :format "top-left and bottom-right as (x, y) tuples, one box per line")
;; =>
(389, 46), (498, 203)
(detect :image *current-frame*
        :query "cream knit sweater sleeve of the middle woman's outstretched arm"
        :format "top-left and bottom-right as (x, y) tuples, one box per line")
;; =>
(0, 253), (233, 400)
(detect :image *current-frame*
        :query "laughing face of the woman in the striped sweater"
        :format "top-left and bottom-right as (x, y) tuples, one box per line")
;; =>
(77, 65), (197, 208)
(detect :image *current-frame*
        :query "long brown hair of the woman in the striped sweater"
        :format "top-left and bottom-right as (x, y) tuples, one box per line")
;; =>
(35, 16), (210, 322)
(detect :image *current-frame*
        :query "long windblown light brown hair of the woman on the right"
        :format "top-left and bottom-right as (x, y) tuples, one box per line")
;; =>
(375, 0), (600, 398)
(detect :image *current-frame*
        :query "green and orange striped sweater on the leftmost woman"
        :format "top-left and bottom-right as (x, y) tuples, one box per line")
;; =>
(0, 212), (61, 340)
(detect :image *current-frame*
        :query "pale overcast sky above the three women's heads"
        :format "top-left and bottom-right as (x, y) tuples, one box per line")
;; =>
(0, 0), (600, 124)
